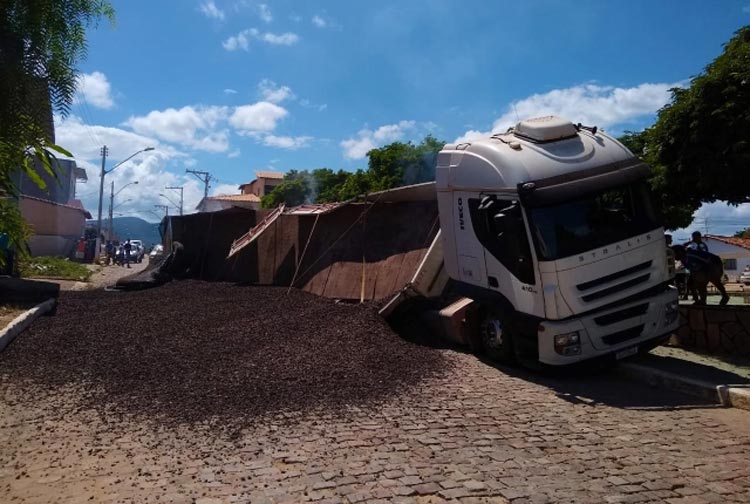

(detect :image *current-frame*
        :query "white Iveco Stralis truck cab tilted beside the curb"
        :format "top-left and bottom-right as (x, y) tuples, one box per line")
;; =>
(436, 116), (679, 365)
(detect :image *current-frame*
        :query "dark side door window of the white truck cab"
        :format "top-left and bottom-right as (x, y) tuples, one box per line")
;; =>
(469, 197), (535, 284)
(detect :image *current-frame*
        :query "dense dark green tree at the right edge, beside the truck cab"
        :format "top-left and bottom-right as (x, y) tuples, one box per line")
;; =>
(643, 26), (750, 228)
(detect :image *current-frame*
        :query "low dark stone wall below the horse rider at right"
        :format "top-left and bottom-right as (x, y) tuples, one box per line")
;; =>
(671, 306), (750, 357)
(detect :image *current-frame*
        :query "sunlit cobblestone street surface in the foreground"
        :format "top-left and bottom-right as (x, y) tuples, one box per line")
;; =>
(0, 350), (750, 504)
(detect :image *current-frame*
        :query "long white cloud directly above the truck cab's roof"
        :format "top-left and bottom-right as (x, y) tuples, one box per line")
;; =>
(456, 83), (681, 142)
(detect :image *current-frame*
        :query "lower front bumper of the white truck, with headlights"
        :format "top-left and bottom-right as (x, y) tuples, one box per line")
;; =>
(537, 288), (679, 366)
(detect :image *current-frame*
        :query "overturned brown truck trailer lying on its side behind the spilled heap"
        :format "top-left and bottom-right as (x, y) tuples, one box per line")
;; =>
(164, 183), (439, 300)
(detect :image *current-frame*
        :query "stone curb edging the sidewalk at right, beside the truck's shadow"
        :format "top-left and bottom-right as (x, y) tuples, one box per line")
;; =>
(617, 362), (750, 411)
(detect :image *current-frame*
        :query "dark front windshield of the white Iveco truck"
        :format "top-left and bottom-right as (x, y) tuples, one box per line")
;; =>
(530, 182), (658, 261)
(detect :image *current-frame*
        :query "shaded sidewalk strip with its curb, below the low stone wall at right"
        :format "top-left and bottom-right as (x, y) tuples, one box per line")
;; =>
(619, 346), (750, 410)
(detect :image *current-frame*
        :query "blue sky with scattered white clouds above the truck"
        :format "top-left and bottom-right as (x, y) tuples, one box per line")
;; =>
(63, 0), (750, 232)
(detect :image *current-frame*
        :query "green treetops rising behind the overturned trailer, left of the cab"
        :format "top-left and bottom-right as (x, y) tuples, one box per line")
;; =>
(261, 136), (445, 208)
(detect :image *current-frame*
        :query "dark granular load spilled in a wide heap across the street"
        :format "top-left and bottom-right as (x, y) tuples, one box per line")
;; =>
(0, 281), (447, 422)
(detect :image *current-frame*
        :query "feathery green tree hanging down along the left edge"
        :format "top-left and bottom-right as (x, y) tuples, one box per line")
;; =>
(0, 0), (114, 264)
